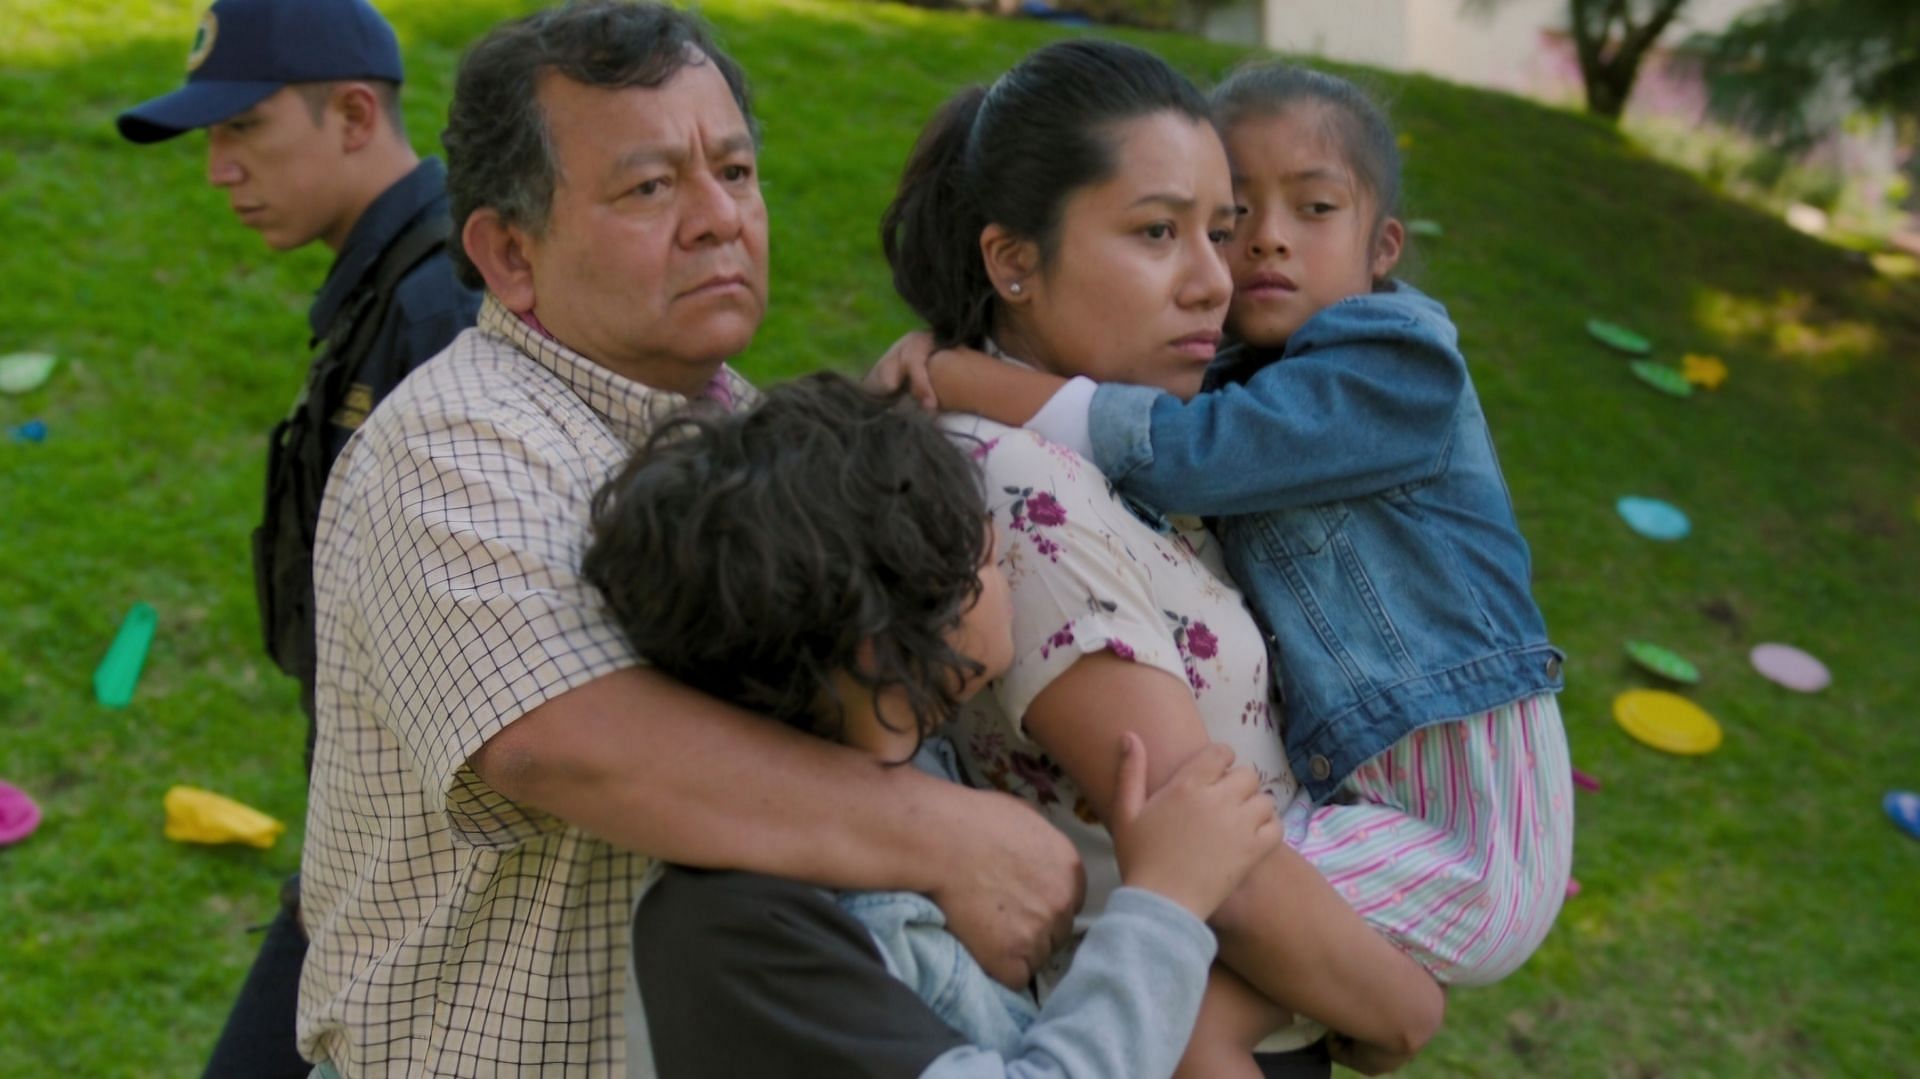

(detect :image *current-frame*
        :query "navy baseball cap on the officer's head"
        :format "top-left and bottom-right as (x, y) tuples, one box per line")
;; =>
(117, 0), (401, 142)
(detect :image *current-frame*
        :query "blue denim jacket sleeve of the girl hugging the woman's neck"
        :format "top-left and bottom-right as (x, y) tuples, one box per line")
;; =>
(1089, 286), (1467, 515)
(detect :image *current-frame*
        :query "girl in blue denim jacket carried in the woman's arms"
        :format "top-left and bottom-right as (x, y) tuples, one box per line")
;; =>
(876, 56), (1572, 1029)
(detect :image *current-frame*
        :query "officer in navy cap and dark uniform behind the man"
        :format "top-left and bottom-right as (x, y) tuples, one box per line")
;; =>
(119, 0), (480, 1077)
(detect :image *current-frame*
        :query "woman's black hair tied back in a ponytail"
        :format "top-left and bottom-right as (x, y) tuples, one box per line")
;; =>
(879, 40), (1208, 348)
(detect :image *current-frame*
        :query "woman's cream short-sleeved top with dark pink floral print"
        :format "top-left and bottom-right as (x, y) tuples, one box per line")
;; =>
(943, 417), (1298, 1036)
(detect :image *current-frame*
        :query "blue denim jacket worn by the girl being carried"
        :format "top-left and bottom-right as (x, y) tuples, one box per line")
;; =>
(1089, 282), (1563, 803)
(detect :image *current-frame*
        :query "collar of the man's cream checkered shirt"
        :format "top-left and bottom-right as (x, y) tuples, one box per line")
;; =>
(478, 292), (755, 445)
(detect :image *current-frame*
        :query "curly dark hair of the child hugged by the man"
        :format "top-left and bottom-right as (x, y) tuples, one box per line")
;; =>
(584, 374), (987, 756)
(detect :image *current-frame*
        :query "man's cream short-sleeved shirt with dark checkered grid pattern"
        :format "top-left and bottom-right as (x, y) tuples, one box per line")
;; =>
(300, 289), (753, 1077)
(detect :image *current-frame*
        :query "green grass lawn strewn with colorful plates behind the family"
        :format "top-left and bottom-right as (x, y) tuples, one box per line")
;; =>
(0, 0), (1920, 1077)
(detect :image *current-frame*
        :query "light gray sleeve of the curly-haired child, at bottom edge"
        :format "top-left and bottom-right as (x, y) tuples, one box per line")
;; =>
(920, 887), (1215, 1079)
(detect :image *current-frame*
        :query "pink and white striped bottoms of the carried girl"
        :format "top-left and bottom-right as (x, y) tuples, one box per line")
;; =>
(1286, 693), (1572, 985)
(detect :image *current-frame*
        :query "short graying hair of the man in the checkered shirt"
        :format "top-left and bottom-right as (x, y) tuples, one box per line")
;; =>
(440, 0), (753, 288)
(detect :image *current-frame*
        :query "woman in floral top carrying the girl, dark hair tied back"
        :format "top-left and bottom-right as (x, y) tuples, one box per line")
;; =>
(883, 40), (1442, 1075)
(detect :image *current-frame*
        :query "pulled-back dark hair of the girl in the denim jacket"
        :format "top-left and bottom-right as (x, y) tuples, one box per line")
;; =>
(1212, 61), (1400, 228)
